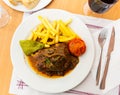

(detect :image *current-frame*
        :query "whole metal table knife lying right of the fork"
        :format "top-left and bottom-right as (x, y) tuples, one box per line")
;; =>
(100, 27), (115, 89)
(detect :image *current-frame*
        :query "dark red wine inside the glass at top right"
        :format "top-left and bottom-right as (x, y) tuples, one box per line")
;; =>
(88, 0), (118, 13)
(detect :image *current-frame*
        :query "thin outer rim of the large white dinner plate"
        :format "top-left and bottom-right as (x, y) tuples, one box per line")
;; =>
(10, 9), (95, 93)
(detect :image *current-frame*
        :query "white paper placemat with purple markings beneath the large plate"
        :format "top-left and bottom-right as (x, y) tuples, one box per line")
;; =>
(9, 9), (120, 95)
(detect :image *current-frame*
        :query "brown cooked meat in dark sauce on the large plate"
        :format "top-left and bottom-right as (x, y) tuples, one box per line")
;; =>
(28, 43), (79, 76)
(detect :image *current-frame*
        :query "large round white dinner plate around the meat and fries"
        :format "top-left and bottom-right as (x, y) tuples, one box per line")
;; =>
(11, 9), (95, 93)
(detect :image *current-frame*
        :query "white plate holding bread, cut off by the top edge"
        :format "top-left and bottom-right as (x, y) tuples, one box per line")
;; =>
(3, 0), (52, 12)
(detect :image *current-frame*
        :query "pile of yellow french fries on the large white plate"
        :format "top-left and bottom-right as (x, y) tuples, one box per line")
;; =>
(29, 16), (77, 47)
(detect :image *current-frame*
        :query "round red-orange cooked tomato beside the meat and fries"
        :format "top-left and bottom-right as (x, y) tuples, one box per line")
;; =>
(68, 38), (86, 56)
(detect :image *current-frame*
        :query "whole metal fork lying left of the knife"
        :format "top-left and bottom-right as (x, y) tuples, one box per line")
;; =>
(96, 28), (107, 85)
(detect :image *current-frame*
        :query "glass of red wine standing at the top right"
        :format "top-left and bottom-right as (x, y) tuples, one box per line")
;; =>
(84, 0), (118, 15)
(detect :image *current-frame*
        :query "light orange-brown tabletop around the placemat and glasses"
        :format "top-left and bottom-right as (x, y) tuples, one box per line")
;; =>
(0, 0), (120, 95)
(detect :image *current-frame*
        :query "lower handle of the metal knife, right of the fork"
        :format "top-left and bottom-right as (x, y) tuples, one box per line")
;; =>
(100, 55), (110, 89)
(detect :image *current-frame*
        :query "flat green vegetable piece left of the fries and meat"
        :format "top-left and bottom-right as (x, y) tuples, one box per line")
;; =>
(20, 40), (44, 56)
